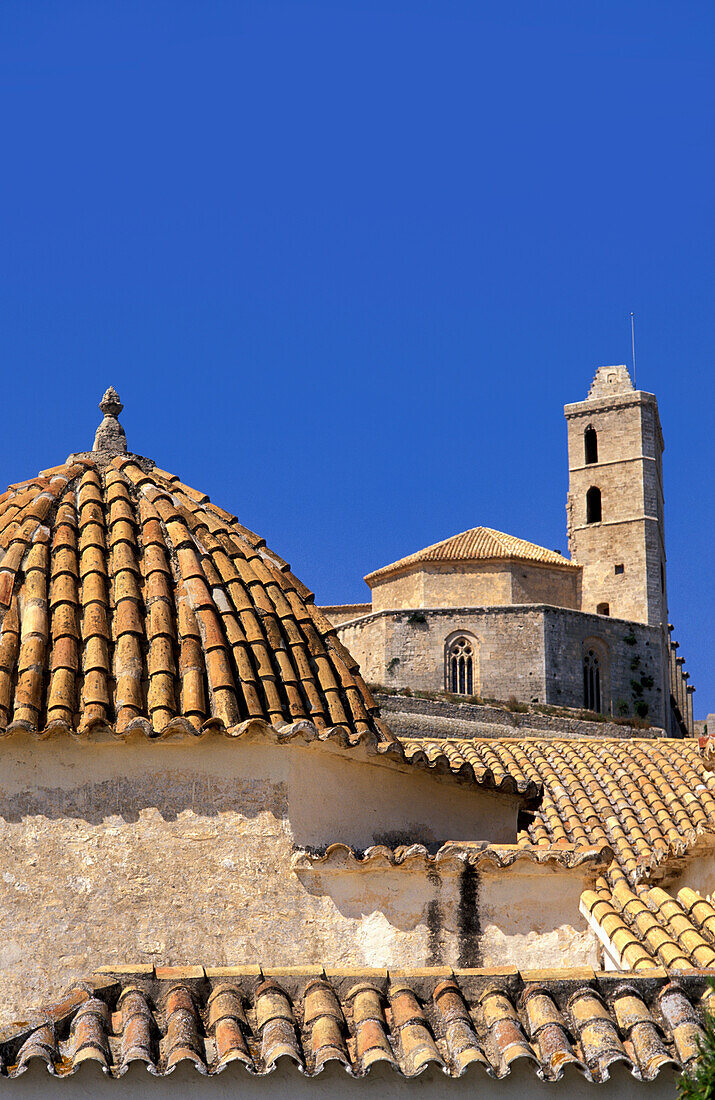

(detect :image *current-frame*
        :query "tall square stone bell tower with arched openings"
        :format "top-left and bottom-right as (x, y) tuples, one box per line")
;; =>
(564, 366), (668, 630)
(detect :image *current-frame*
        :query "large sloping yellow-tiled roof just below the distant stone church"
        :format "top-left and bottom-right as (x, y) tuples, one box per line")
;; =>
(403, 738), (715, 882)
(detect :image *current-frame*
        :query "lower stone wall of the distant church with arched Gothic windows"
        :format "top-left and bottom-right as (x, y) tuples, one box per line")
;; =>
(339, 606), (666, 726)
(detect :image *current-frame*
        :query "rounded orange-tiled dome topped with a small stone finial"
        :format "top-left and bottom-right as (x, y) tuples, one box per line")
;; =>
(0, 391), (393, 741)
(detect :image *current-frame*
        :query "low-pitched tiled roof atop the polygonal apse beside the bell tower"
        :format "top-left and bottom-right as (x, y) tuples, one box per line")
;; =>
(365, 527), (580, 585)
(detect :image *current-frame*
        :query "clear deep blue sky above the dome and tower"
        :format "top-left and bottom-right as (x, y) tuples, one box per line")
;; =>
(0, 0), (715, 715)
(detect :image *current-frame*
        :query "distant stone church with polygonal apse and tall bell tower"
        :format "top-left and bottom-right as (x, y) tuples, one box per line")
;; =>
(322, 366), (694, 737)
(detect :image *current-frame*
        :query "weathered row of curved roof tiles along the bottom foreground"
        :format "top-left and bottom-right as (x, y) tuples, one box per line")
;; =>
(0, 967), (710, 1090)
